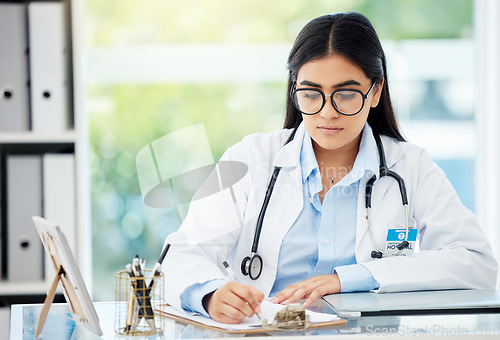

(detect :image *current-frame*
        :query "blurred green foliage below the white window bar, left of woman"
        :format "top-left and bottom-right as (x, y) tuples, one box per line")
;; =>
(88, 84), (285, 300)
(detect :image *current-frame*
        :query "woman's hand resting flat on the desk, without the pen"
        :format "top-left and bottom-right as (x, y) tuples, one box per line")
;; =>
(271, 274), (340, 307)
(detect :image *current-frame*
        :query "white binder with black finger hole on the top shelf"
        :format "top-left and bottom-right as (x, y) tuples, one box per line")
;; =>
(28, 2), (70, 132)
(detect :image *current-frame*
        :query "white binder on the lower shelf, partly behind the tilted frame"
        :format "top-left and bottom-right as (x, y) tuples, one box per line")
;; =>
(42, 153), (76, 278)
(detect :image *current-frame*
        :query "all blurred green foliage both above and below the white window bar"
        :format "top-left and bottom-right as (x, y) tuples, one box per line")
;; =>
(85, 0), (473, 300)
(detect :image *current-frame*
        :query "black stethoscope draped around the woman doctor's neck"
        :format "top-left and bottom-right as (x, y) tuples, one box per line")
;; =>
(241, 128), (410, 280)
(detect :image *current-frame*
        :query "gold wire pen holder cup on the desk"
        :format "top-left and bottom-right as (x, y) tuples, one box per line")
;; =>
(115, 269), (165, 336)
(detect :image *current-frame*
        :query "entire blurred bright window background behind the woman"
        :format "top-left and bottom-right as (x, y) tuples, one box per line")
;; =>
(85, 0), (477, 301)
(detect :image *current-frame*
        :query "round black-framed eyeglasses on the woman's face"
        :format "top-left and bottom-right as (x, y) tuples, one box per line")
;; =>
(290, 83), (376, 116)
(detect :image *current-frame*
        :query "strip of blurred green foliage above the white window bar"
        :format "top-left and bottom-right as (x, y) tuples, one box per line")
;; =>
(86, 0), (473, 46)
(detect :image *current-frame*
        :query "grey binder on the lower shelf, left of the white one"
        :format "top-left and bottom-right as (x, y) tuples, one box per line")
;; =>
(5, 154), (43, 281)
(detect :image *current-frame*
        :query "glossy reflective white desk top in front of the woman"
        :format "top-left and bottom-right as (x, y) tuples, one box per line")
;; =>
(10, 302), (500, 340)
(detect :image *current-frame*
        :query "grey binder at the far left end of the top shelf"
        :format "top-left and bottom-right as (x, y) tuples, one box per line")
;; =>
(0, 3), (30, 131)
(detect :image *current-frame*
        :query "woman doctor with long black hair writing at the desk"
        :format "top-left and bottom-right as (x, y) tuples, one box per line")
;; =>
(163, 13), (497, 323)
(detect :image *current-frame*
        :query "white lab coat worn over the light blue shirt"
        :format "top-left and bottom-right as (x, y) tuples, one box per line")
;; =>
(163, 124), (497, 308)
